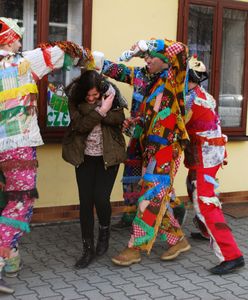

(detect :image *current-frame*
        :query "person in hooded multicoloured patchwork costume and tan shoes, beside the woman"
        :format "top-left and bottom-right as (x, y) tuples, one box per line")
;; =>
(95, 39), (190, 266)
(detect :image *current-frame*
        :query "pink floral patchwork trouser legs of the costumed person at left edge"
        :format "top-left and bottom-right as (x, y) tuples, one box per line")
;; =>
(0, 147), (38, 292)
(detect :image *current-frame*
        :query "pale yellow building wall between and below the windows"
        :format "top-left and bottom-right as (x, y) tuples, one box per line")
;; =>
(36, 0), (248, 207)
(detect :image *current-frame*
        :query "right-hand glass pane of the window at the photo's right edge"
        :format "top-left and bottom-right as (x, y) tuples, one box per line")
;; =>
(218, 9), (247, 127)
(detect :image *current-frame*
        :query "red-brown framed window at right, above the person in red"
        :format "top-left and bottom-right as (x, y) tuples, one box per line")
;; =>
(178, 0), (248, 137)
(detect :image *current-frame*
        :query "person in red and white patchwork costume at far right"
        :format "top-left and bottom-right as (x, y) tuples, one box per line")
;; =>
(184, 56), (245, 275)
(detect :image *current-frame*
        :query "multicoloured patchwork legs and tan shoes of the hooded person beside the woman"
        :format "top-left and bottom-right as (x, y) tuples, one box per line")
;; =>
(112, 144), (190, 266)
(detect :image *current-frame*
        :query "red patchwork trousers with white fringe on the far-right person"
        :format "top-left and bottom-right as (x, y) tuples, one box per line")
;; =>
(187, 165), (242, 262)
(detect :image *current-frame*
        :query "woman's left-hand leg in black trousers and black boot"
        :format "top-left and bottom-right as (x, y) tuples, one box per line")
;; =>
(75, 155), (96, 269)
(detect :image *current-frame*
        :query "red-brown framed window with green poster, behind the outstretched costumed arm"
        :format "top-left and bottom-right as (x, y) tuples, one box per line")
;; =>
(0, 0), (92, 141)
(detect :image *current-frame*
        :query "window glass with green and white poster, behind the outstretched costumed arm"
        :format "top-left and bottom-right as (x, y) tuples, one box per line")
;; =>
(46, 0), (82, 127)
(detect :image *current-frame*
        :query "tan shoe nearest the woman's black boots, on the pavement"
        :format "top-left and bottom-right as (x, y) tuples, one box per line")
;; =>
(112, 247), (141, 266)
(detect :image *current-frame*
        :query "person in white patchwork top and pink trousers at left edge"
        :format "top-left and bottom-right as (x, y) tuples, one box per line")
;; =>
(0, 17), (94, 293)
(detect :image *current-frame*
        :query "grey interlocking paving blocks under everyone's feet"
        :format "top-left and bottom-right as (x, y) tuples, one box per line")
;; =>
(0, 210), (248, 300)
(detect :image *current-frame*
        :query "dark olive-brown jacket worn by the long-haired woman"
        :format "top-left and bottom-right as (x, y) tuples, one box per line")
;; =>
(62, 102), (126, 168)
